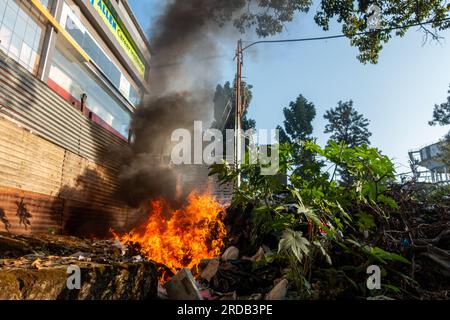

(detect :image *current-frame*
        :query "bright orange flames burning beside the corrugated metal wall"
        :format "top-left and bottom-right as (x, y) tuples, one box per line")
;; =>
(116, 192), (226, 272)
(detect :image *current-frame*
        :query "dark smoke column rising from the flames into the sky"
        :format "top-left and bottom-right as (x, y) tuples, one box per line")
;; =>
(119, 0), (242, 206)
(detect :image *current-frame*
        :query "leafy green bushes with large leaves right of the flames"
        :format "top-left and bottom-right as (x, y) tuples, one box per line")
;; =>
(211, 141), (409, 299)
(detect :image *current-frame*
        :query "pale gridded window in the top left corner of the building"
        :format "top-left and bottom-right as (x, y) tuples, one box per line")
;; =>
(0, 0), (43, 73)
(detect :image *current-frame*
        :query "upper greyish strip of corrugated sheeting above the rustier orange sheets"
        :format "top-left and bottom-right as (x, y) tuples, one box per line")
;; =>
(0, 52), (126, 167)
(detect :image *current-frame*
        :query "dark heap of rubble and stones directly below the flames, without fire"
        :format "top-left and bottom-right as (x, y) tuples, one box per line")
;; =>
(158, 246), (288, 300)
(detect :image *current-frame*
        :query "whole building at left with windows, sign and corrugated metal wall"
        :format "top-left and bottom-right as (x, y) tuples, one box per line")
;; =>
(0, 0), (151, 234)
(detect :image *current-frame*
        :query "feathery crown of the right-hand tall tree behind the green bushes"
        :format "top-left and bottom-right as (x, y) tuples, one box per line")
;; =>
(324, 100), (372, 147)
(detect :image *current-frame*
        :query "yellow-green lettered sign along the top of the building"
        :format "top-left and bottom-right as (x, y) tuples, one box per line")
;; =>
(90, 0), (145, 77)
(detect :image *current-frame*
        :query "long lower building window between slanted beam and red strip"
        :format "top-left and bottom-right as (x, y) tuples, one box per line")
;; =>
(49, 47), (131, 138)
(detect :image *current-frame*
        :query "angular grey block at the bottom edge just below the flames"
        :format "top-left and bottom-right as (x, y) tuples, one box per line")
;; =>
(166, 269), (203, 300)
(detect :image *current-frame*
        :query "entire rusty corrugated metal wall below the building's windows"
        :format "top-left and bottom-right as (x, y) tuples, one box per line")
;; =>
(0, 52), (134, 236)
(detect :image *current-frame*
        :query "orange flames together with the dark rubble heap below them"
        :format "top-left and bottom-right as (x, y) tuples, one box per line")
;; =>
(107, 193), (287, 300)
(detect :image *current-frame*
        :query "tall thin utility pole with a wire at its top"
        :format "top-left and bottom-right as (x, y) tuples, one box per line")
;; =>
(234, 40), (242, 187)
